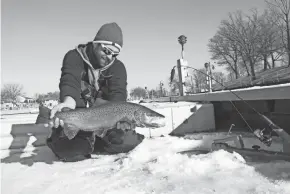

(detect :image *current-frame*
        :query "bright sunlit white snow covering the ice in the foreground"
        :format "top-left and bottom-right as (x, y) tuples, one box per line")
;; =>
(1, 104), (290, 194)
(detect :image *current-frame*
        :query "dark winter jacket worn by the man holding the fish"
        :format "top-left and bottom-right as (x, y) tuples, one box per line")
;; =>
(59, 44), (127, 107)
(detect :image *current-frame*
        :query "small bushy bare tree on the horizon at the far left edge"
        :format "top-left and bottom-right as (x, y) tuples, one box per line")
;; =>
(1, 84), (24, 102)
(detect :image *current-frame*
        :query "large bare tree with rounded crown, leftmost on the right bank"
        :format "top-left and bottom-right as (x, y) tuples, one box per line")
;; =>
(208, 9), (266, 79)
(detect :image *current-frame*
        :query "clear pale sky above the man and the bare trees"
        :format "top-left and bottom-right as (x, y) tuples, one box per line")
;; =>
(1, 0), (266, 97)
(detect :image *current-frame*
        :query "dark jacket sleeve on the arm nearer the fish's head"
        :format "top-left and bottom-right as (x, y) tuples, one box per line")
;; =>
(108, 61), (127, 101)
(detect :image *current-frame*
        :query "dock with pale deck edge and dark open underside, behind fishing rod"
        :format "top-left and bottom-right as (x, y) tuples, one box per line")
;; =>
(151, 84), (290, 135)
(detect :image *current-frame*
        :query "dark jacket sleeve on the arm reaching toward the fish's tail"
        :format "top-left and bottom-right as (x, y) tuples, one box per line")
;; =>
(59, 50), (82, 104)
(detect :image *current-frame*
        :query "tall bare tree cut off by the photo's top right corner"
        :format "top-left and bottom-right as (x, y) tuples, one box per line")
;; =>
(265, 0), (290, 66)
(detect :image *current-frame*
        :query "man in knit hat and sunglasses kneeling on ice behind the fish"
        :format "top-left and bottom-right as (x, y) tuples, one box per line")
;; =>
(36, 23), (144, 161)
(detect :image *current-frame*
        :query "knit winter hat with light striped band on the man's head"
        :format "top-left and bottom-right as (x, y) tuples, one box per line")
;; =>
(93, 22), (123, 51)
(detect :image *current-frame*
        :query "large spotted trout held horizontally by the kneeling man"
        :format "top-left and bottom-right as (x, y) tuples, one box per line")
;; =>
(43, 102), (165, 139)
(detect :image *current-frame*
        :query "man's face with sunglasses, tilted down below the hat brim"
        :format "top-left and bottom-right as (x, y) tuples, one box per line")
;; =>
(93, 43), (118, 67)
